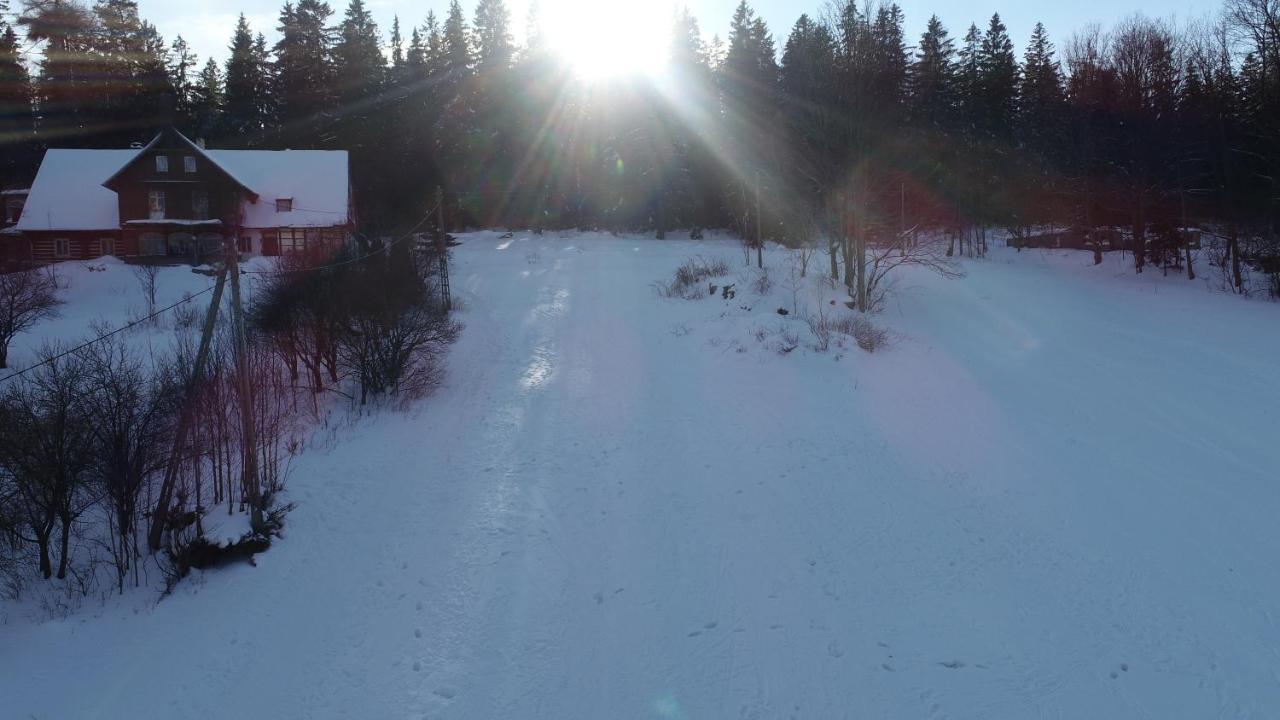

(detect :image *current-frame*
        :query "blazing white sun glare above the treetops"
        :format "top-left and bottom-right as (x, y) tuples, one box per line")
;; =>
(543, 0), (669, 81)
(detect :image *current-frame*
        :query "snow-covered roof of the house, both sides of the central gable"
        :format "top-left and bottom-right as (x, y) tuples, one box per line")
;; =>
(17, 142), (349, 231)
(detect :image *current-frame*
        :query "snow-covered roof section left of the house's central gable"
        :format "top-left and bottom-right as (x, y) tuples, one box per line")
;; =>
(15, 150), (138, 231)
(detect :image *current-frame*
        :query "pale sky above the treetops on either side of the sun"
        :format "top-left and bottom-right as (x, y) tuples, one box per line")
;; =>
(138, 0), (1221, 67)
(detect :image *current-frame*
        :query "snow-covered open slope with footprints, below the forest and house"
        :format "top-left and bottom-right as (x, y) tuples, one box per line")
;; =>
(0, 233), (1280, 720)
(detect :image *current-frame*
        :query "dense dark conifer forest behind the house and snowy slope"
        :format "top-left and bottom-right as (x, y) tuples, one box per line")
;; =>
(0, 0), (1280, 288)
